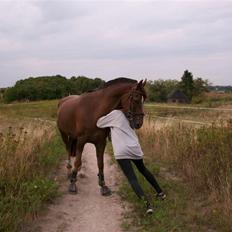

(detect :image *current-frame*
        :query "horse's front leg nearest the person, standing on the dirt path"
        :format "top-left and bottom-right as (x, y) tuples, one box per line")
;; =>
(95, 141), (111, 196)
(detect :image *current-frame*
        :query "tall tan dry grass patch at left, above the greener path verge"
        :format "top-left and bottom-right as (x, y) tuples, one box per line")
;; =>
(0, 122), (55, 191)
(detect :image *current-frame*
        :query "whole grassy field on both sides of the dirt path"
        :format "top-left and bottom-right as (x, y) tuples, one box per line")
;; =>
(0, 101), (232, 232)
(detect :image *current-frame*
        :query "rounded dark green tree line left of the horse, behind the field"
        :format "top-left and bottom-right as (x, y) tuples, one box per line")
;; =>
(3, 75), (104, 103)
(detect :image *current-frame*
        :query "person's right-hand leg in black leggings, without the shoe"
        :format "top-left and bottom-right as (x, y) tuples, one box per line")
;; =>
(133, 159), (163, 194)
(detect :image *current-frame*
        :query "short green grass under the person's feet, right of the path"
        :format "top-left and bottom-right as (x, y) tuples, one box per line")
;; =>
(119, 159), (232, 232)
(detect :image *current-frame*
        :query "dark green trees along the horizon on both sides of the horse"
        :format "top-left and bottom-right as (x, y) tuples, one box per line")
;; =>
(1, 70), (209, 103)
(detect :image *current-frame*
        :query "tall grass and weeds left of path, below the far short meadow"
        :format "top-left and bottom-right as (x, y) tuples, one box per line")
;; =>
(0, 120), (63, 231)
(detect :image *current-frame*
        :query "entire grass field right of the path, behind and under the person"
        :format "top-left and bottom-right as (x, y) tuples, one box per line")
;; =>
(112, 105), (232, 232)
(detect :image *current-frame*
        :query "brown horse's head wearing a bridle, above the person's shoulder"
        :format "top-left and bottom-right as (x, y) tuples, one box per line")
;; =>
(121, 80), (146, 129)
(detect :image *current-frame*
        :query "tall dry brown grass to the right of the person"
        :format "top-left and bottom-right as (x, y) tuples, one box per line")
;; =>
(139, 120), (232, 214)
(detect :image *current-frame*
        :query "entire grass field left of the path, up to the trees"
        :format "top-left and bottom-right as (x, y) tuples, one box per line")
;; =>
(0, 101), (65, 232)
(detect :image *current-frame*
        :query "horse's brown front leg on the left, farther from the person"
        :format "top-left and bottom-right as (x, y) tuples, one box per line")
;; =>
(69, 140), (84, 193)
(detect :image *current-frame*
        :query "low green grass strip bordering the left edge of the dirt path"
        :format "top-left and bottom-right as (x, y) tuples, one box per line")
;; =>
(0, 131), (65, 232)
